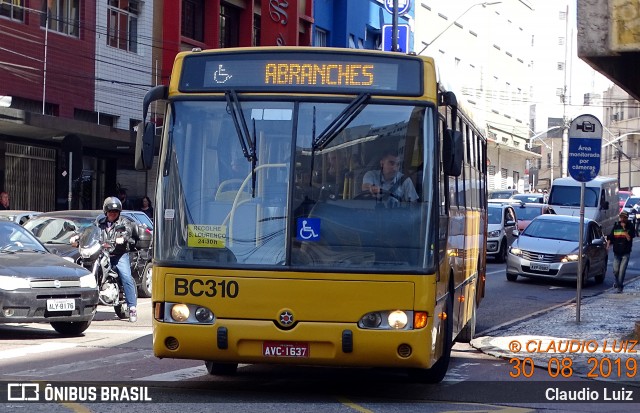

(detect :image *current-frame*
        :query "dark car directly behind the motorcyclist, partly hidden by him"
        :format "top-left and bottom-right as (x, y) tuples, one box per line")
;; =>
(25, 210), (153, 297)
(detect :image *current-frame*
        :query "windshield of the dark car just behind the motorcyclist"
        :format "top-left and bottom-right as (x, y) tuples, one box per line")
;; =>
(24, 216), (95, 244)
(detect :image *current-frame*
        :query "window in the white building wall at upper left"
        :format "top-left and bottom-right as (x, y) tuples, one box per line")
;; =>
(107, 0), (140, 53)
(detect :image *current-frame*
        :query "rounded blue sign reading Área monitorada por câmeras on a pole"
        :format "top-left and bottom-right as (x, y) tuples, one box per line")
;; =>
(567, 115), (602, 182)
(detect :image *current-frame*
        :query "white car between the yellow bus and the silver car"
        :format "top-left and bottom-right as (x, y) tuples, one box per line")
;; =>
(487, 202), (517, 262)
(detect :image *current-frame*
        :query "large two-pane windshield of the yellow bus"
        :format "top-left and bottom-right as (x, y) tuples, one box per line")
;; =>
(156, 95), (439, 272)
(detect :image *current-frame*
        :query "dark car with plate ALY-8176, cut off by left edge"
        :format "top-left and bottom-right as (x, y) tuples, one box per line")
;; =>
(0, 221), (98, 335)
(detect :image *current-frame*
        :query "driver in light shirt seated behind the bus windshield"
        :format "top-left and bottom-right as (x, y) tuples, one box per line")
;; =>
(362, 152), (418, 202)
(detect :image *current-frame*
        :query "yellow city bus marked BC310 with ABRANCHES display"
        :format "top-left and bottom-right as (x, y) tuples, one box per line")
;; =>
(136, 47), (487, 382)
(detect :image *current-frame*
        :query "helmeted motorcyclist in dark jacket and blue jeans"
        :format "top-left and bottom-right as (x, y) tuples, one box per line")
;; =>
(97, 196), (138, 323)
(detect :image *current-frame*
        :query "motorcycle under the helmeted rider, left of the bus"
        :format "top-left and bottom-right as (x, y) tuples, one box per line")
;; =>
(78, 225), (129, 319)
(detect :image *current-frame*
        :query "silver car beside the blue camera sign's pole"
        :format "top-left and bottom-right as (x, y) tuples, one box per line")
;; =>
(507, 214), (608, 285)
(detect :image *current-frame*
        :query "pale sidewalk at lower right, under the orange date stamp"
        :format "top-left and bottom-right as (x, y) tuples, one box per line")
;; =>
(471, 268), (640, 384)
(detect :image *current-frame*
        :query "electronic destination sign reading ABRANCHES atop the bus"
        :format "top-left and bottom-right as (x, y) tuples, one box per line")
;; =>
(179, 52), (423, 96)
